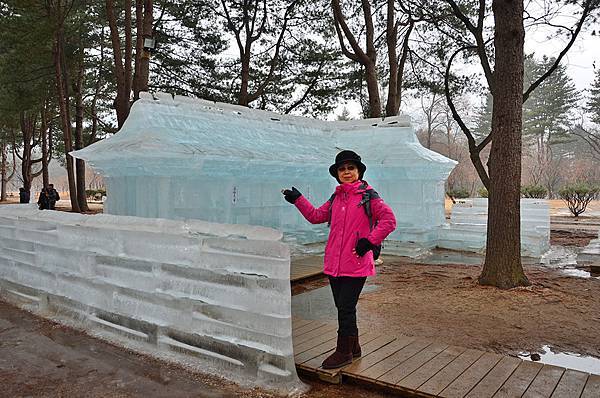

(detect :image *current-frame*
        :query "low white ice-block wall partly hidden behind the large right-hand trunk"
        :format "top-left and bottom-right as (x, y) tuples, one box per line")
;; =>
(438, 198), (550, 257)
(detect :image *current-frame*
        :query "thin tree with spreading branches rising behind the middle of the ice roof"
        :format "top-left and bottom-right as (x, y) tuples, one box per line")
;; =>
(215, 0), (348, 116)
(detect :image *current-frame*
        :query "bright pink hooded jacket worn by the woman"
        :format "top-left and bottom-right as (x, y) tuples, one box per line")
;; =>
(295, 181), (396, 277)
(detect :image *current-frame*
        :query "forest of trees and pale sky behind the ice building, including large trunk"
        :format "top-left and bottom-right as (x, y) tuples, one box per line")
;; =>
(0, 0), (600, 287)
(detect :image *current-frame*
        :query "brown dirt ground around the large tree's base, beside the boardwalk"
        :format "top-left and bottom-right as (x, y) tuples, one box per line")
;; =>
(359, 260), (600, 357)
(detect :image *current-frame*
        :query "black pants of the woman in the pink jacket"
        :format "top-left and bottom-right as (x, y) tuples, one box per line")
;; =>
(329, 276), (367, 336)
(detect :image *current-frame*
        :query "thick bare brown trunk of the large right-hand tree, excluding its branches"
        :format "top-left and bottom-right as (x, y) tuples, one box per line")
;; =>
(479, 0), (529, 289)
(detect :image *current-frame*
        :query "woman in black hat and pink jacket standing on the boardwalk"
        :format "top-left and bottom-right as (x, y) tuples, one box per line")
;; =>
(282, 151), (396, 369)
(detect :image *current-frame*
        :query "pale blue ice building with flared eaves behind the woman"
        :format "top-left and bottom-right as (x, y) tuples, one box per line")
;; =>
(73, 93), (456, 250)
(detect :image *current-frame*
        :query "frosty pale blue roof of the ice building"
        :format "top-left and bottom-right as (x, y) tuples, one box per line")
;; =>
(72, 93), (455, 174)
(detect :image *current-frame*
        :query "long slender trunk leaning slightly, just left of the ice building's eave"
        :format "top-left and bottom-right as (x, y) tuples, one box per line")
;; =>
(53, 21), (81, 213)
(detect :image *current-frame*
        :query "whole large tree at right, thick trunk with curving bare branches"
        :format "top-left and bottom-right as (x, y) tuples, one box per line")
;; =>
(444, 0), (598, 289)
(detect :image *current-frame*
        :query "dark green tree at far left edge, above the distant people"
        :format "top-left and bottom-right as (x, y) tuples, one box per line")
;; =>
(0, 0), (53, 196)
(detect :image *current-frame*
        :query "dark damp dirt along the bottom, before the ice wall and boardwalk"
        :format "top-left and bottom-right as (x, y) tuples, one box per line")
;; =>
(0, 301), (388, 398)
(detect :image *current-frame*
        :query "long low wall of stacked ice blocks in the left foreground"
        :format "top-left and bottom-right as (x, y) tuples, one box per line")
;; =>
(0, 205), (304, 394)
